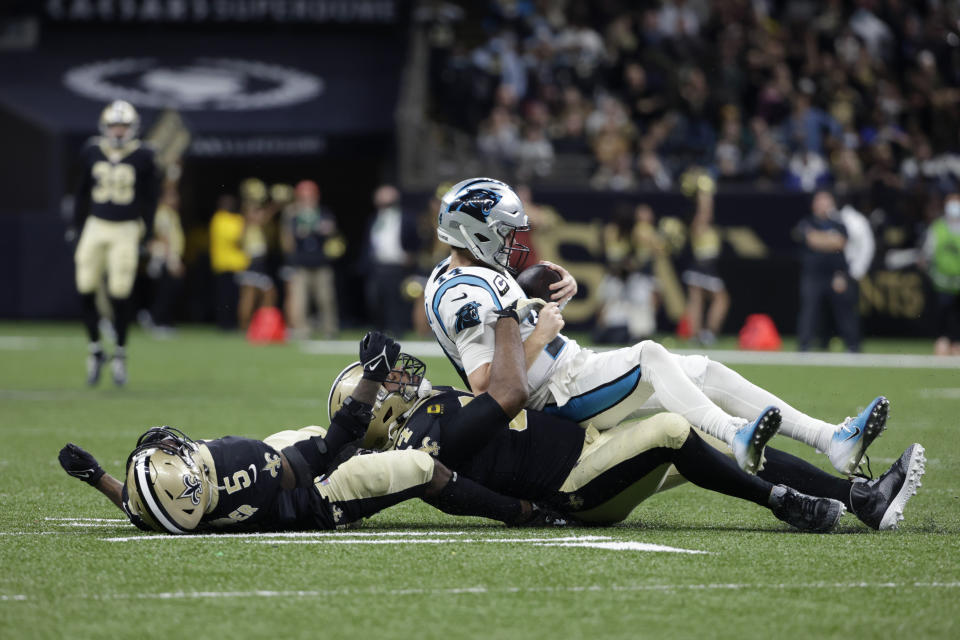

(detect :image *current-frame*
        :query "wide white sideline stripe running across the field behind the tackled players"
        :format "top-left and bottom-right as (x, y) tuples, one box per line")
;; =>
(300, 340), (960, 369)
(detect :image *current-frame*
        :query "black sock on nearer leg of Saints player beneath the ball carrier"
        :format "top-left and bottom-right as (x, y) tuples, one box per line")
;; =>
(673, 429), (773, 507)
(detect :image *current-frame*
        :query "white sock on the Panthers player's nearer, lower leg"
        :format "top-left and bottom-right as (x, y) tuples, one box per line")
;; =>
(640, 342), (759, 444)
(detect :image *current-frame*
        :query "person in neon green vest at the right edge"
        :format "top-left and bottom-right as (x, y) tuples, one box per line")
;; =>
(923, 189), (960, 355)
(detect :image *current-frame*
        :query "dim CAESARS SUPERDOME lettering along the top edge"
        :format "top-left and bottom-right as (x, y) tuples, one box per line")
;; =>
(44, 0), (397, 24)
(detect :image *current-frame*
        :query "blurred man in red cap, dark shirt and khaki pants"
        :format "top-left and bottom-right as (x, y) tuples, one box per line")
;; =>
(280, 180), (346, 339)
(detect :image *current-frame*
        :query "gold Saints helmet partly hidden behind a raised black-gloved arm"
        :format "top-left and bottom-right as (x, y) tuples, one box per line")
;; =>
(327, 353), (433, 451)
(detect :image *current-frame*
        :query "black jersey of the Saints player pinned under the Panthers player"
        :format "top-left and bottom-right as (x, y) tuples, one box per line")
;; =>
(396, 389), (585, 500)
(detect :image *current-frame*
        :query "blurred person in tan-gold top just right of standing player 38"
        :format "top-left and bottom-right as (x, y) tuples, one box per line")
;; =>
(140, 182), (186, 335)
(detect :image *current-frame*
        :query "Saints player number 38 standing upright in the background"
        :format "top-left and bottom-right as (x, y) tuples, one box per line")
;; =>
(68, 100), (160, 386)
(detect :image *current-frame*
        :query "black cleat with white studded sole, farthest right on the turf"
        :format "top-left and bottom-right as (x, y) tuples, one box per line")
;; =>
(850, 443), (927, 531)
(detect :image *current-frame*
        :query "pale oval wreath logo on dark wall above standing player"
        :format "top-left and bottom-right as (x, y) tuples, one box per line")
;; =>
(63, 58), (324, 111)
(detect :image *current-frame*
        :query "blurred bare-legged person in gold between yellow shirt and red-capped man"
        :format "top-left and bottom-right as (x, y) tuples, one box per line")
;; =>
(237, 178), (277, 330)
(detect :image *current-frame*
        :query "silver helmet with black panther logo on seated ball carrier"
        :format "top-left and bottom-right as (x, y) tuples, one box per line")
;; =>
(437, 178), (530, 273)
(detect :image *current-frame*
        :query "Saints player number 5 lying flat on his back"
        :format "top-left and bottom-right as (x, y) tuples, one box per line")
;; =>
(59, 333), (565, 534)
